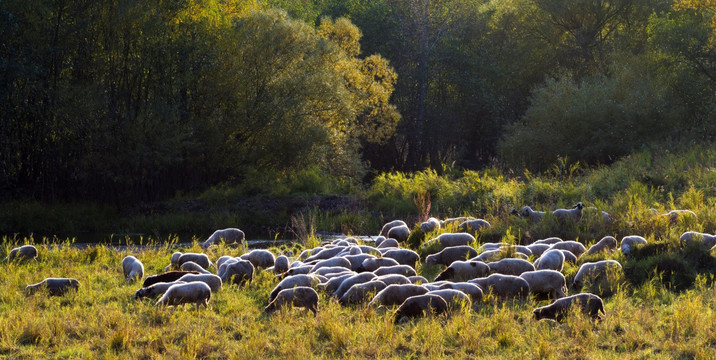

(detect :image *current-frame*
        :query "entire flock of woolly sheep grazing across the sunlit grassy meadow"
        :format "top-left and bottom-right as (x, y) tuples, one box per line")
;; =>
(5, 203), (716, 322)
